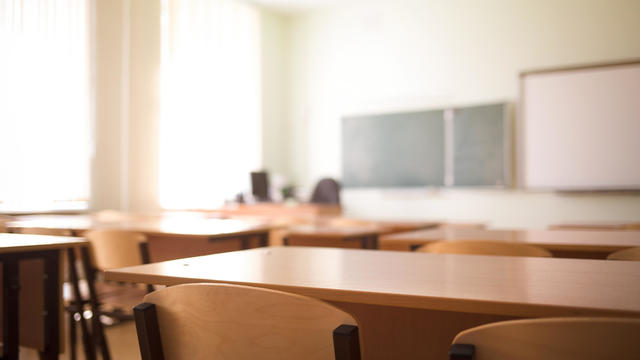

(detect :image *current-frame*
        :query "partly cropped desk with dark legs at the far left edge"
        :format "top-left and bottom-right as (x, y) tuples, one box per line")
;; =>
(0, 234), (87, 359)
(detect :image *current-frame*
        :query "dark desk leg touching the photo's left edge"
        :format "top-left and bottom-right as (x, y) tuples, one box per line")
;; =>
(2, 255), (20, 360)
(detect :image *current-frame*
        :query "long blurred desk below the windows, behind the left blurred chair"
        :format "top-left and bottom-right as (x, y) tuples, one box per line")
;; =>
(7, 215), (274, 261)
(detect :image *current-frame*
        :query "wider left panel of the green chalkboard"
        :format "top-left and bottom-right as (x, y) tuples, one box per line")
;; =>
(342, 110), (444, 188)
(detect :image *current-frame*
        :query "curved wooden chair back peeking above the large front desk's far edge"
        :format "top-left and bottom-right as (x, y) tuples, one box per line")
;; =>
(416, 240), (552, 257)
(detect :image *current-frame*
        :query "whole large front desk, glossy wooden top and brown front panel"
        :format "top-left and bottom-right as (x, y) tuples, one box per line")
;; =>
(105, 247), (640, 360)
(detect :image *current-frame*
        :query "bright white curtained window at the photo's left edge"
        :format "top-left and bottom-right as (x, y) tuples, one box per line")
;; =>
(0, 0), (92, 211)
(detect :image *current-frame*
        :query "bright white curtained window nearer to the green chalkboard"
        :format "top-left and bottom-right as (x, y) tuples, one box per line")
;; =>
(159, 0), (261, 209)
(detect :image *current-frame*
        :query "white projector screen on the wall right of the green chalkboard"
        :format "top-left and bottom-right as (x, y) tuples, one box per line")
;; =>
(519, 61), (640, 191)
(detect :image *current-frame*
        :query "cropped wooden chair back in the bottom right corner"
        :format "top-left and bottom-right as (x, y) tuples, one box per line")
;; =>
(449, 318), (640, 360)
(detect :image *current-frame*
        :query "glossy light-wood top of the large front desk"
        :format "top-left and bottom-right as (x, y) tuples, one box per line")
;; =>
(106, 247), (640, 316)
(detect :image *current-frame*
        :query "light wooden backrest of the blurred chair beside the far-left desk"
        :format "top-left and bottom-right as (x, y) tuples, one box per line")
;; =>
(84, 229), (146, 270)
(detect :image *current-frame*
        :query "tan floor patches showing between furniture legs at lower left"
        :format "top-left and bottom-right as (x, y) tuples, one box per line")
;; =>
(20, 321), (140, 360)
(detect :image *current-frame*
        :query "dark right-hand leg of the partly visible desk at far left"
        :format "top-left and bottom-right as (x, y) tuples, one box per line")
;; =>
(44, 250), (60, 359)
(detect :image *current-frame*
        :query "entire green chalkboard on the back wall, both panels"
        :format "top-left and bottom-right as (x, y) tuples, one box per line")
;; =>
(342, 103), (511, 188)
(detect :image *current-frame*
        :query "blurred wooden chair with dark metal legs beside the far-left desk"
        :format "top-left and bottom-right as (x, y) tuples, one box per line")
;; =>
(67, 230), (153, 359)
